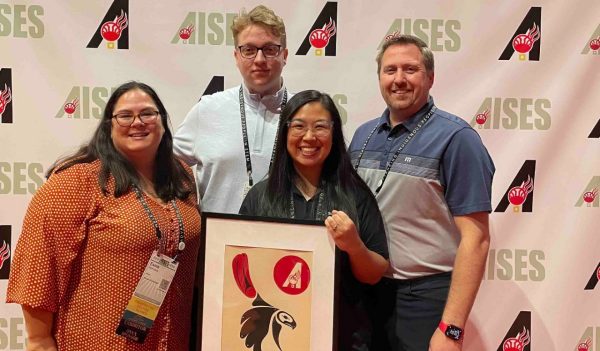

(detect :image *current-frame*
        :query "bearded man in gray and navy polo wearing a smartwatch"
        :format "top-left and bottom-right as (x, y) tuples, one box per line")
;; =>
(349, 35), (495, 351)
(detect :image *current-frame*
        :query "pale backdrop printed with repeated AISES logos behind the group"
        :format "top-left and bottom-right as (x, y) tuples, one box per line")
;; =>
(0, 0), (600, 351)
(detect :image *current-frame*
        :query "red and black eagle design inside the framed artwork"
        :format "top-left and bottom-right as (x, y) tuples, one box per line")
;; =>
(232, 253), (296, 351)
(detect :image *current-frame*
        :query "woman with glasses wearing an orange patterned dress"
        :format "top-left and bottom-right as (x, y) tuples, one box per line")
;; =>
(7, 82), (200, 351)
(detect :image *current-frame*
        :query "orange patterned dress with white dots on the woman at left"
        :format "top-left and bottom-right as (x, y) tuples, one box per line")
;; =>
(6, 161), (200, 351)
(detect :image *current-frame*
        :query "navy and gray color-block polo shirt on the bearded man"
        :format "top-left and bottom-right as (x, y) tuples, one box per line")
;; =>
(349, 97), (495, 279)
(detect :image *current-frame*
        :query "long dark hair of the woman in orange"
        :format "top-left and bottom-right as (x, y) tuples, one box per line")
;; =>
(46, 81), (194, 201)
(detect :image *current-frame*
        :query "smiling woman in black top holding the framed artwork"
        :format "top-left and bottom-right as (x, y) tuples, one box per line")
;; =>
(240, 90), (388, 350)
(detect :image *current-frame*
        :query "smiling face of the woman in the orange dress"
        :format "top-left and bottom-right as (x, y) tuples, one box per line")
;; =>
(111, 89), (165, 163)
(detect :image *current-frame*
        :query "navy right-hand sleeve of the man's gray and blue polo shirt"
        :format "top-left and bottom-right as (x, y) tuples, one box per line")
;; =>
(441, 128), (495, 216)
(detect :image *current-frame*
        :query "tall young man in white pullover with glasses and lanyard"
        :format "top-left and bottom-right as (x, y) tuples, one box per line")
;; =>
(174, 5), (290, 213)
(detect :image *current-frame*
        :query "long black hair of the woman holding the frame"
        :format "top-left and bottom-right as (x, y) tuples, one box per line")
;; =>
(259, 90), (373, 227)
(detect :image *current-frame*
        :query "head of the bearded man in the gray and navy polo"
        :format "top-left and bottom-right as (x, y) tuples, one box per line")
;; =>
(379, 44), (434, 123)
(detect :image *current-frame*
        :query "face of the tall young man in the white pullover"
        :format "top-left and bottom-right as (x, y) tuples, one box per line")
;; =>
(234, 24), (288, 95)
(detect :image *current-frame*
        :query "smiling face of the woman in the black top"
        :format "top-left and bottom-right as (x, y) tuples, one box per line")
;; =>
(287, 102), (333, 177)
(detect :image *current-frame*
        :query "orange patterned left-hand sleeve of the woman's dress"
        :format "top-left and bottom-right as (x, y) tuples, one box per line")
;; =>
(6, 164), (99, 312)
